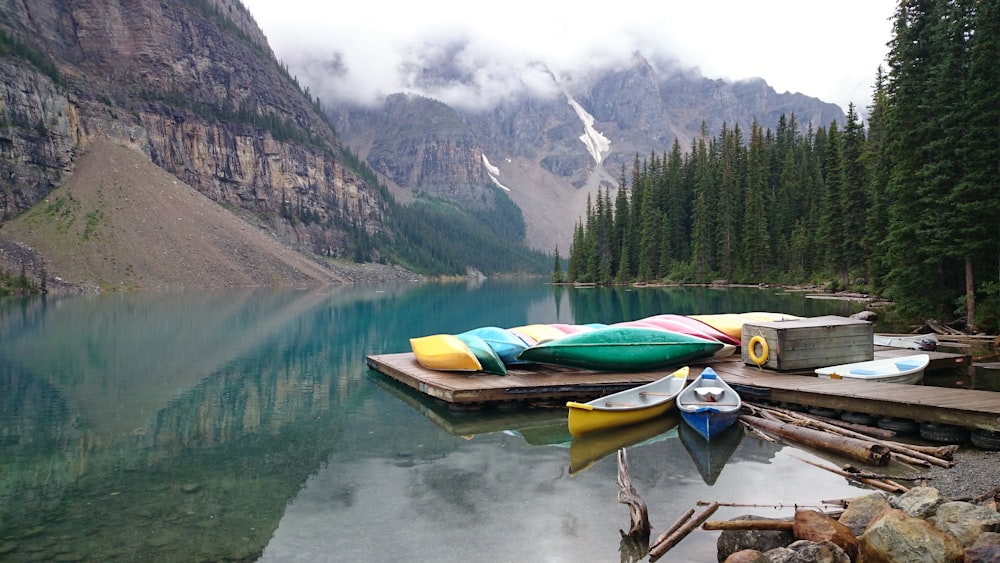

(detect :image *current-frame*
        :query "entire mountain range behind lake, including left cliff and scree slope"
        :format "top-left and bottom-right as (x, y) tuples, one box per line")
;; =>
(0, 0), (840, 288)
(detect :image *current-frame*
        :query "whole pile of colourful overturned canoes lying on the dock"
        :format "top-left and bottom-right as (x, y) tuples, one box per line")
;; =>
(410, 313), (798, 375)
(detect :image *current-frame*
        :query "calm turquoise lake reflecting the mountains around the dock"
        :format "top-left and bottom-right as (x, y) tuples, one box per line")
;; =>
(0, 280), (916, 562)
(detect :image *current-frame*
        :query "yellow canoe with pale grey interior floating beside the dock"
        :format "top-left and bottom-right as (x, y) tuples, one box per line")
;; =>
(566, 366), (689, 436)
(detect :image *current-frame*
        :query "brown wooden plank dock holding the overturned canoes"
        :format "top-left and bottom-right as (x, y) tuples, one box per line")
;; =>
(367, 347), (1000, 431)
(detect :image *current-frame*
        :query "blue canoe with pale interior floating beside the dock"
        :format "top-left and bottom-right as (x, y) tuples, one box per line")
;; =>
(677, 367), (743, 441)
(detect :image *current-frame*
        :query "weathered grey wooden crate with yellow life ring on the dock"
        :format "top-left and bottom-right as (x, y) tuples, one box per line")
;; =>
(741, 316), (875, 371)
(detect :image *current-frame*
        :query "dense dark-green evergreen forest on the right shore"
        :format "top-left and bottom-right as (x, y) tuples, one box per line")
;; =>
(564, 0), (1000, 333)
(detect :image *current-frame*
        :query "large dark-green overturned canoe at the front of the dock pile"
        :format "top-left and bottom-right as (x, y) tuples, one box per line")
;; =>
(517, 326), (723, 371)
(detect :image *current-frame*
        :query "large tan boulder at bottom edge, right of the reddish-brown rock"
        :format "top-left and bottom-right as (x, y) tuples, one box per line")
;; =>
(857, 509), (963, 563)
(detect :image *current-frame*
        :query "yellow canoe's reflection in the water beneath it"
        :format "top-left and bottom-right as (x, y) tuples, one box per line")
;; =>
(569, 412), (682, 476)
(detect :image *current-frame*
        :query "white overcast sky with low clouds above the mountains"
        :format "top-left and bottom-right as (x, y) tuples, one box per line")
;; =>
(243, 0), (896, 113)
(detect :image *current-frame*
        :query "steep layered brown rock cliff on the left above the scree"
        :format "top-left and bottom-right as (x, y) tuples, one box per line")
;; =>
(0, 0), (385, 256)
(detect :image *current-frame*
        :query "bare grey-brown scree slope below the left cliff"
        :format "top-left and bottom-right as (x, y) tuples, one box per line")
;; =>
(0, 140), (417, 291)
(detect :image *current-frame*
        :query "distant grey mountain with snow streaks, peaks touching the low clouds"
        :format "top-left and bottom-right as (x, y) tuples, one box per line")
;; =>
(326, 54), (844, 256)
